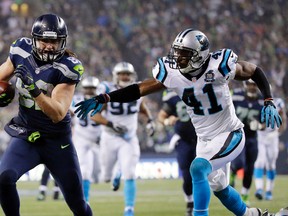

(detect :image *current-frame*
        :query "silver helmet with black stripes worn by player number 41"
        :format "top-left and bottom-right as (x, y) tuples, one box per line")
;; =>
(168, 28), (209, 73)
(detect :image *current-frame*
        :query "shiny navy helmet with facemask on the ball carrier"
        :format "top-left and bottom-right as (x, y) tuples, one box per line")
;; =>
(31, 14), (68, 62)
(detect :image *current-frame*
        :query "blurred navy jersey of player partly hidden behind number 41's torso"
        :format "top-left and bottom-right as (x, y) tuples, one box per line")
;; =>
(162, 91), (197, 143)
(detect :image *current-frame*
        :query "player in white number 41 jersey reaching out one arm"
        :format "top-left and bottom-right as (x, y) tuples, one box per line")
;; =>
(76, 28), (281, 216)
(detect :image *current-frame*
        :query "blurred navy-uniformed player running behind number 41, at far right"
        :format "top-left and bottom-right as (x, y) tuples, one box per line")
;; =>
(230, 79), (263, 206)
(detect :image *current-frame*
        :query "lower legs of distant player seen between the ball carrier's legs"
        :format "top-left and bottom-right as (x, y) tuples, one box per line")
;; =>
(37, 166), (60, 201)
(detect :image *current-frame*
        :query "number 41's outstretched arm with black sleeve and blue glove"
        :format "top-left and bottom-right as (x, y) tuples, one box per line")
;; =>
(75, 79), (165, 119)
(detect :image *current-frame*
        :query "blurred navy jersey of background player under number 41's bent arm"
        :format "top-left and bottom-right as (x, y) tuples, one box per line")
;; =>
(232, 89), (263, 137)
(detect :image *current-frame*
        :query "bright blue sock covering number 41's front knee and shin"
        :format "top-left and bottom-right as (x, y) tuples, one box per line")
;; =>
(190, 158), (212, 216)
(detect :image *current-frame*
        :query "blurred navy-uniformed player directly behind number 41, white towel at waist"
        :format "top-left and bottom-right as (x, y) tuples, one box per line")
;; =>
(158, 88), (197, 216)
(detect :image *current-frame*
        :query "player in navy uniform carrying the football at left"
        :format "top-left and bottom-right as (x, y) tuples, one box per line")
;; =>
(0, 14), (92, 216)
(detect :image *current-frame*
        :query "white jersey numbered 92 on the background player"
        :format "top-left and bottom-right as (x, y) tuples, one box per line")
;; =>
(97, 82), (142, 139)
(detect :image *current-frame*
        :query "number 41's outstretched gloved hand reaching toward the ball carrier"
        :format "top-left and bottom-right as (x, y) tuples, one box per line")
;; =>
(74, 94), (110, 119)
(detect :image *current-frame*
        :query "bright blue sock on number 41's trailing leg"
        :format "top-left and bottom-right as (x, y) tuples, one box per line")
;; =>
(214, 185), (246, 216)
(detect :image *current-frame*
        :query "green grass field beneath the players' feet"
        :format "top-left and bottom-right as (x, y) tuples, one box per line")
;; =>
(0, 176), (288, 216)
